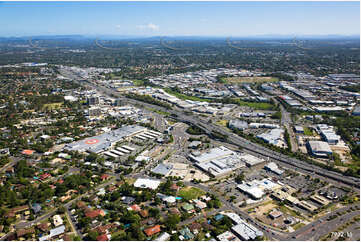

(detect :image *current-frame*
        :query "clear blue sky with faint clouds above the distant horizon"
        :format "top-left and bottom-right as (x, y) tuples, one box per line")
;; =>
(0, 1), (360, 37)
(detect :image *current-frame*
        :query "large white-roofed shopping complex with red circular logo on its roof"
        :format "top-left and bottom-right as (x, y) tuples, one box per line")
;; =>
(64, 125), (147, 153)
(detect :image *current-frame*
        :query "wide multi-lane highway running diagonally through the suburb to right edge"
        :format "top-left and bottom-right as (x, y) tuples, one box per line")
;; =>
(61, 67), (360, 191)
